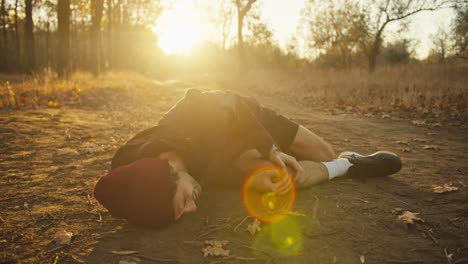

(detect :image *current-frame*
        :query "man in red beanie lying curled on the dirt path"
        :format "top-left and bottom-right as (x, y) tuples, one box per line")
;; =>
(94, 89), (401, 227)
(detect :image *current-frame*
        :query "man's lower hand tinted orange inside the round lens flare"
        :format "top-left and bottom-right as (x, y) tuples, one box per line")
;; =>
(252, 167), (293, 195)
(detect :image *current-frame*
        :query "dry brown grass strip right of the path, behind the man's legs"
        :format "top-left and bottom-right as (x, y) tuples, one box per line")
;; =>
(224, 65), (468, 122)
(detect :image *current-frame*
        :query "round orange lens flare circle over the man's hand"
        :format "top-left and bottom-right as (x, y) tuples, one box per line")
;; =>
(242, 166), (296, 223)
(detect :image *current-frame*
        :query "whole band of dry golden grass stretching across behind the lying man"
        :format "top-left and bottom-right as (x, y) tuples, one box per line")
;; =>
(0, 64), (468, 125)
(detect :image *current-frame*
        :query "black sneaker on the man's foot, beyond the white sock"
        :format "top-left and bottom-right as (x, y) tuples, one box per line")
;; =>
(338, 151), (401, 178)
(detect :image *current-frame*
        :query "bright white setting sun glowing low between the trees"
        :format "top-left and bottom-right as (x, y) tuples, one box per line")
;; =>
(153, 1), (202, 55)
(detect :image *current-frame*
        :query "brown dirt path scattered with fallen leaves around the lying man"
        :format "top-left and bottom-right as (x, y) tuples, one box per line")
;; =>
(0, 87), (468, 263)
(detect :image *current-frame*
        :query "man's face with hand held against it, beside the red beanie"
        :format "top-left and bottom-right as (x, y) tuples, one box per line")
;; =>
(173, 172), (200, 220)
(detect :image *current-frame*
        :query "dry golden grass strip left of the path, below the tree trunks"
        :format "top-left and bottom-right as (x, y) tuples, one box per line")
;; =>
(0, 70), (154, 109)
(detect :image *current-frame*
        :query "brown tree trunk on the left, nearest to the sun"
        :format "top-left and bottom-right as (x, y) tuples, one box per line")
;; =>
(90, 0), (104, 76)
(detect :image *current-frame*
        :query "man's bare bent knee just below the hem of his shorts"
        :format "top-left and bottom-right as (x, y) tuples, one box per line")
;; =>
(288, 125), (336, 162)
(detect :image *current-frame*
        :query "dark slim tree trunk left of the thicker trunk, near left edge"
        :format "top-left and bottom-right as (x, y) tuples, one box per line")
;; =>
(24, 0), (36, 72)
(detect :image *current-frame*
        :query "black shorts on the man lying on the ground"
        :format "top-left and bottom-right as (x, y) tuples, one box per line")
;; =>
(247, 99), (299, 152)
